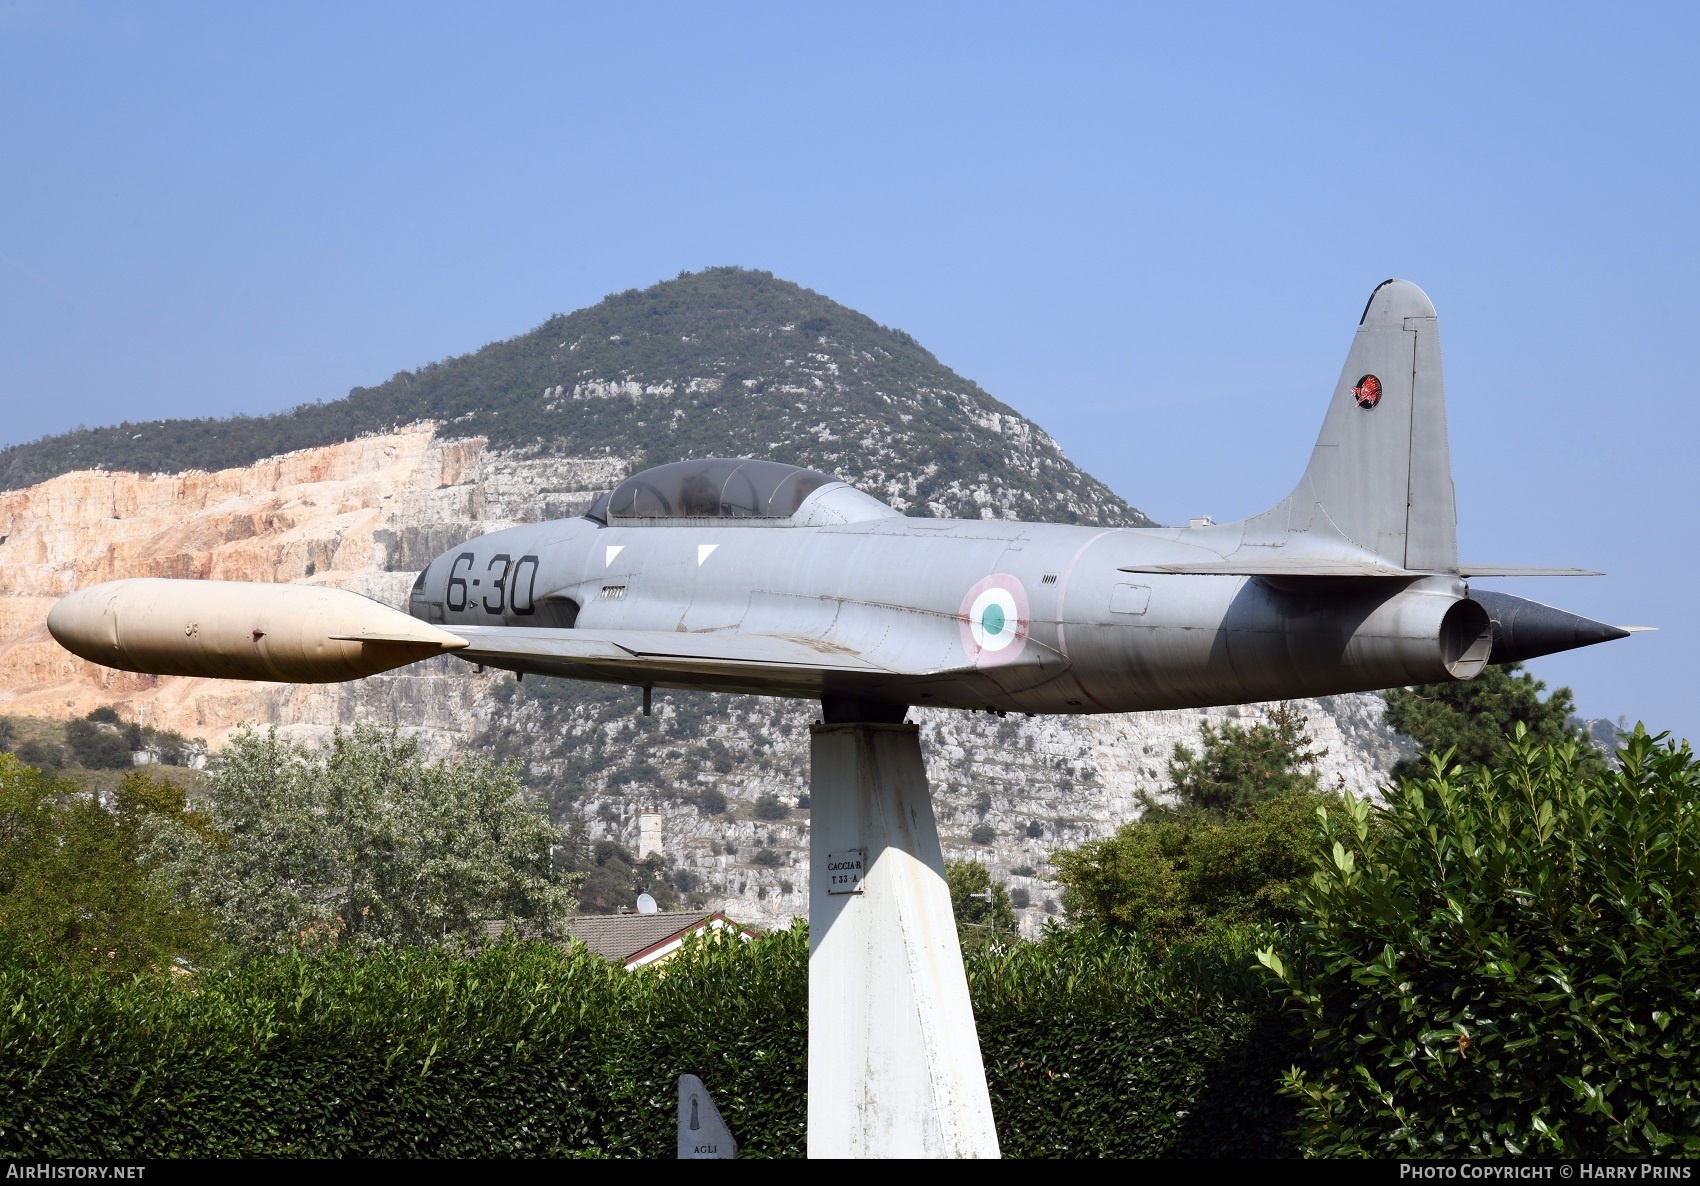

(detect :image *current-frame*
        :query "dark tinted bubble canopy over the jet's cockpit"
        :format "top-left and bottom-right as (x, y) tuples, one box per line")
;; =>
(605, 457), (838, 518)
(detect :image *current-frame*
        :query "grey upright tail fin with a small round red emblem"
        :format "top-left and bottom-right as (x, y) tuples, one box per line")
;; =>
(1243, 280), (1459, 573)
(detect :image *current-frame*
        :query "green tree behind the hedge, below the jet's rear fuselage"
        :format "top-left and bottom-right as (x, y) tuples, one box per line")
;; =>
(1051, 705), (1335, 943)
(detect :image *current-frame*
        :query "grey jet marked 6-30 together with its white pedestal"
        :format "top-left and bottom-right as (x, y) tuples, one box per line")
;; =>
(48, 280), (1625, 1157)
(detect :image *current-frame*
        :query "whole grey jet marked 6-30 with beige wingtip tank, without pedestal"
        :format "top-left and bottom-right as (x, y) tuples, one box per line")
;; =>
(48, 280), (1627, 722)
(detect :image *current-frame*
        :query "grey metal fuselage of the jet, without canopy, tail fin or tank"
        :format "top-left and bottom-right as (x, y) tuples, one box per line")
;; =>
(415, 502), (1465, 712)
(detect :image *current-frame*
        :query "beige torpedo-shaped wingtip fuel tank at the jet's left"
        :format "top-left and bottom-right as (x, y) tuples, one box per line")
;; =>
(48, 578), (468, 683)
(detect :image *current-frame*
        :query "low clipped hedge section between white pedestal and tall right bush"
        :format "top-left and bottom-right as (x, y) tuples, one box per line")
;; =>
(967, 928), (1307, 1157)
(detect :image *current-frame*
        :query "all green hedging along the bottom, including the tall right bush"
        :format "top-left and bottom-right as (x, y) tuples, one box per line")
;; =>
(16, 731), (1700, 1157)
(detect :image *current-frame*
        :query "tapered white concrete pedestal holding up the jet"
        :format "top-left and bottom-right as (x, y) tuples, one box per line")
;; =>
(809, 724), (998, 1157)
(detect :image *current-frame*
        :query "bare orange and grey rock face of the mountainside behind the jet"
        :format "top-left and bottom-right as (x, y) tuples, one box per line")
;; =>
(0, 419), (1399, 929)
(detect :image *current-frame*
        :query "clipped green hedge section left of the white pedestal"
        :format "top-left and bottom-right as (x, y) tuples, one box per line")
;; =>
(0, 935), (808, 1157)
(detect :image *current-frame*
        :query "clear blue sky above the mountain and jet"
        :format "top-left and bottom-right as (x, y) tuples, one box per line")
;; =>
(0, 0), (1700, 736)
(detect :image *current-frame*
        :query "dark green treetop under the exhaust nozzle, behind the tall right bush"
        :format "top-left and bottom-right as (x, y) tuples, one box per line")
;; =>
(1382, 663), (1607, 782)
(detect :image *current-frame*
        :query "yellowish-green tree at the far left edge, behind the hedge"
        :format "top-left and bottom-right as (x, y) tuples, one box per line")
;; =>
(0, 754), (214, 974)
